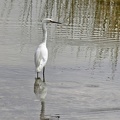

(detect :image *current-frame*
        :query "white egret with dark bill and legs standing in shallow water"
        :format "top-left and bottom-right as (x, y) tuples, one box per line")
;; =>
(34, 18), (61, 82)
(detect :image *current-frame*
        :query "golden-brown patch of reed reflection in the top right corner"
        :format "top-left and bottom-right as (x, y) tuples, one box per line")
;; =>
(94, 0), (120, 40)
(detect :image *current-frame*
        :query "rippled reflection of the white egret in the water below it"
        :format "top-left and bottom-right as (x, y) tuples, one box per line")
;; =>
(34, 78), (60, 120)
